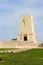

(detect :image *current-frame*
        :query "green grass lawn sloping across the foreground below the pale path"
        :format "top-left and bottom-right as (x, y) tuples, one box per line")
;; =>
(0, 49), (43, 65)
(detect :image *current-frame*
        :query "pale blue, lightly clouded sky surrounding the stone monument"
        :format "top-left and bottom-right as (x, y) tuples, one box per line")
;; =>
(0, 0), (43, 42)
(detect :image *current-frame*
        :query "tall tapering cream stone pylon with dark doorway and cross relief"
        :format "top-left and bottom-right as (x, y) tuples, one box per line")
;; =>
(17, 15), (36, 43)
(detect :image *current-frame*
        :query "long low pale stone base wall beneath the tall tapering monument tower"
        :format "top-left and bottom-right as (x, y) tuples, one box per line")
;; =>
(0, 41), (38, 48)
